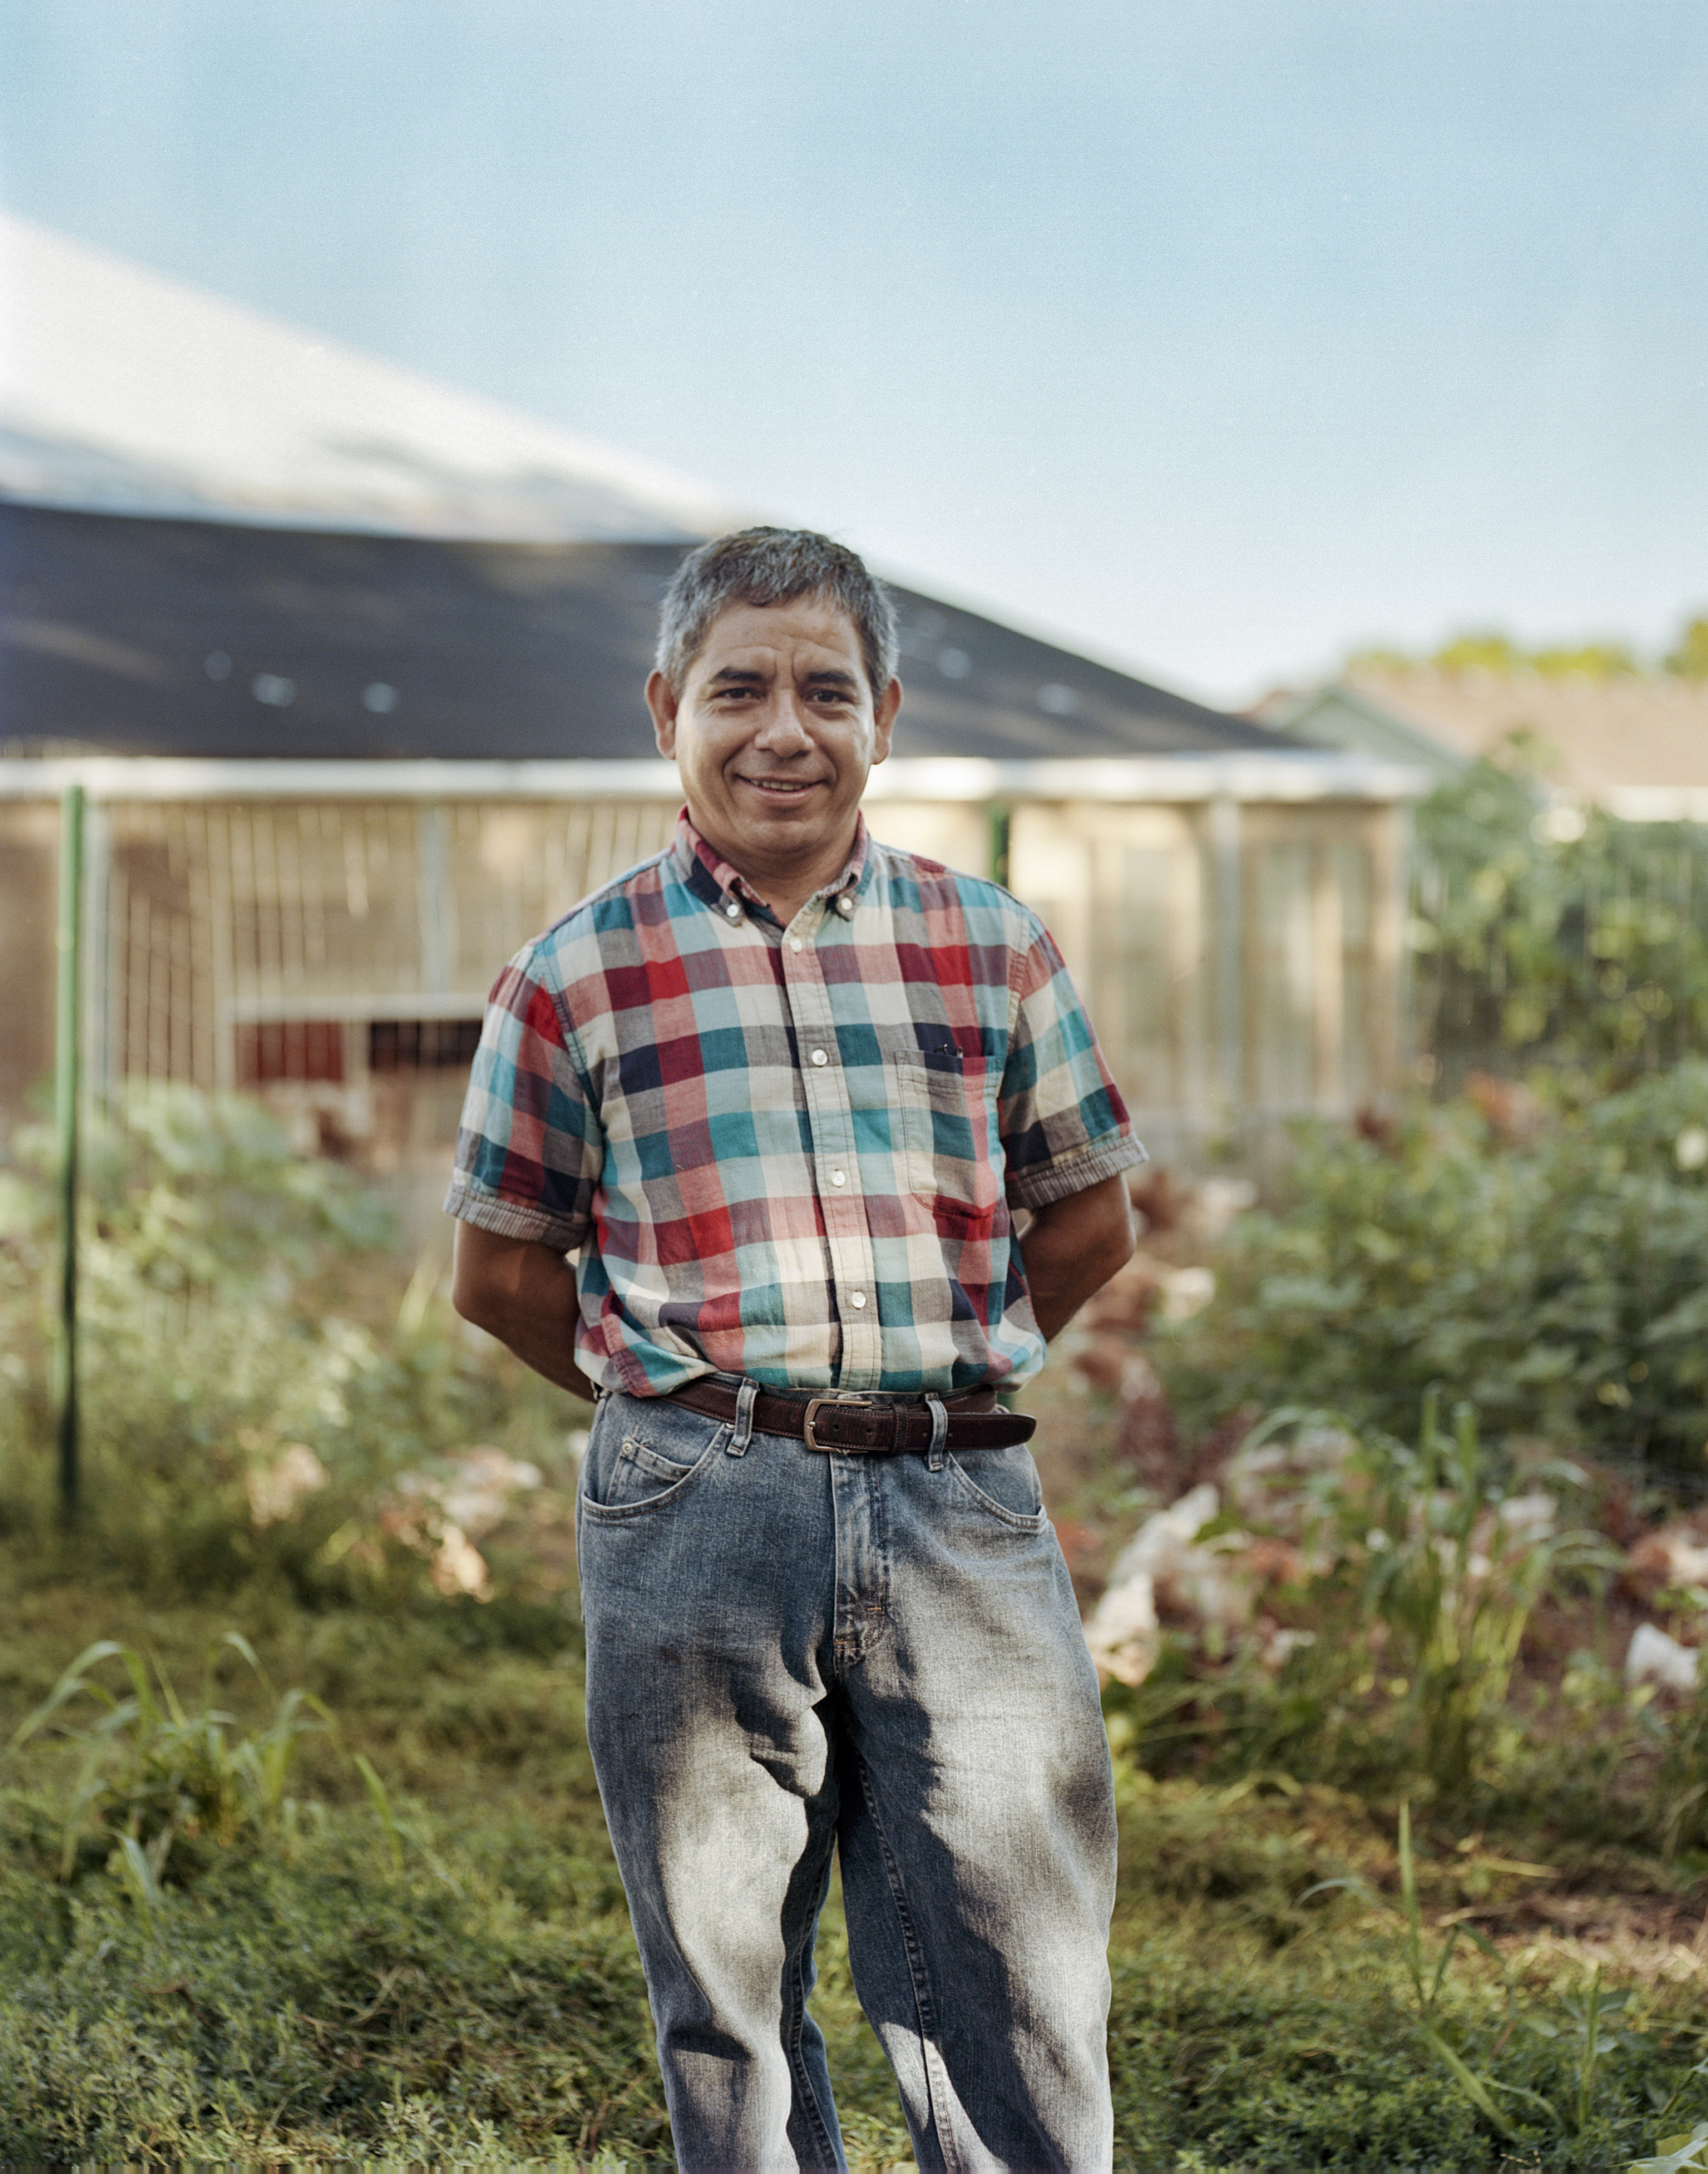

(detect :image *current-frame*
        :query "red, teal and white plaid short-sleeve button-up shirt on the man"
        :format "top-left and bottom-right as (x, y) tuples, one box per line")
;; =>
(445, 815), (1145, 1396)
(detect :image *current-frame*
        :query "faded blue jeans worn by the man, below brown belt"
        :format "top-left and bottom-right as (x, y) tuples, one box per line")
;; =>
(578, 1396), (1115, 2174)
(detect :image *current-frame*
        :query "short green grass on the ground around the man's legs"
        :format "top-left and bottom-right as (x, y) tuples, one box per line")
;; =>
(0, 1546), (1708, 2170)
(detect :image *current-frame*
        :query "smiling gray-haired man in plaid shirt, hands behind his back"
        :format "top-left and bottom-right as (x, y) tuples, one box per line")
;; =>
(448, 528), (1143, 2174)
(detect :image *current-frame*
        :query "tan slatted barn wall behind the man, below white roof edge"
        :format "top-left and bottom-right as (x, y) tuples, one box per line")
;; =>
(0, 800), (1406, 1165)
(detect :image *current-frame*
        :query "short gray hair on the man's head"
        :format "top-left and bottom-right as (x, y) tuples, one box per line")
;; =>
(654, 528), (898, 700)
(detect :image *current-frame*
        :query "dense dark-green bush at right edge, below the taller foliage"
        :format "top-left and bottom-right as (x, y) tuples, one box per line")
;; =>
(1154, 1061), (1708, 1478)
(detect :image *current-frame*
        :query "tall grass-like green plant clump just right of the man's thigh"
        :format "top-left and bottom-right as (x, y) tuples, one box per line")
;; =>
(1104, 1394), (1608, 1805)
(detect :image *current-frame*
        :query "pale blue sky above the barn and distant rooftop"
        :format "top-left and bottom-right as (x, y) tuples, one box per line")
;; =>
(0, 0), (1708, 702)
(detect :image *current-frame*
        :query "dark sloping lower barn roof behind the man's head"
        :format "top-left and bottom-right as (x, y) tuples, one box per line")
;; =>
(0, 502), (1277, 761)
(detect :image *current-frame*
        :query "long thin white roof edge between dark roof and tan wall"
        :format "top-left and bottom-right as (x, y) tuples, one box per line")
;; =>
(0, 752), (1425, 819)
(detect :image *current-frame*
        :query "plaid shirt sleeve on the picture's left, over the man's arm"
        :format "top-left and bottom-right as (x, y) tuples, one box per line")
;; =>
(445, 946), (604, 1253)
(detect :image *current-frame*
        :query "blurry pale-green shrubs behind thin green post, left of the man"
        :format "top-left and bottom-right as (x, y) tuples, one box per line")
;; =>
(0, 1087), (576, 1600)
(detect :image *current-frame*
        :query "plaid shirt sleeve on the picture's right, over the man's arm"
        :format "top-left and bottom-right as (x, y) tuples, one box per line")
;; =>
(997, 921), (1147, 1208)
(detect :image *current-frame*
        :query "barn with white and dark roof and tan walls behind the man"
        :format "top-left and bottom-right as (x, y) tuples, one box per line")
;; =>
(0, 222), (1419, 1179)
